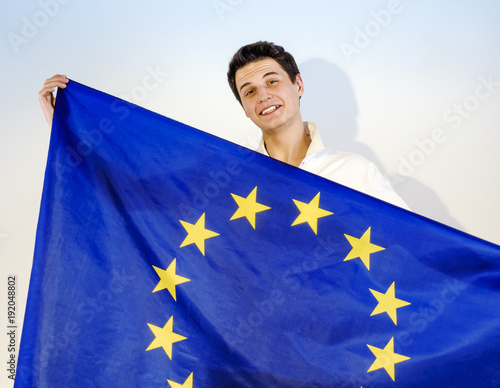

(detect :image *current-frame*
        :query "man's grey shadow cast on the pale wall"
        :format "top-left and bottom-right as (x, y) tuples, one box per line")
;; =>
(299, 59), (462, 229)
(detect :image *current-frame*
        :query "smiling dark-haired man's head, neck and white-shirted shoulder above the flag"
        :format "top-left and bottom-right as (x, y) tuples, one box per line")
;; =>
(227, 42), (407, 208)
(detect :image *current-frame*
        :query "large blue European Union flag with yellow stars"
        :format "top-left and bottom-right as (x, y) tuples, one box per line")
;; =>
(15, 81), (500, 388)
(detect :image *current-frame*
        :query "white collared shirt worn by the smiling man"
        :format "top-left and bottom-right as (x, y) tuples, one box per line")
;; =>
(256, 122), (408, 209)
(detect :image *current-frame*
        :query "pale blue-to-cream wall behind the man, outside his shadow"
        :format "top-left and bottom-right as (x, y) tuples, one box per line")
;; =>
(0, 0), (500, 386)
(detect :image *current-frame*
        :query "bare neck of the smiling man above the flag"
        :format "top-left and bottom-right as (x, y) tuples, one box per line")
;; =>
(262, 120), (311, 167)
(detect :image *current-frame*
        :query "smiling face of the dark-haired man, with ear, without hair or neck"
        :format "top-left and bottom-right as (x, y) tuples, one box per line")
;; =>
(235, 58), (304, 132)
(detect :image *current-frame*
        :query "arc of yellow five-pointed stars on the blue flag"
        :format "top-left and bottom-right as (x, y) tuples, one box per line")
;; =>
(146, 186), (410, 388)
